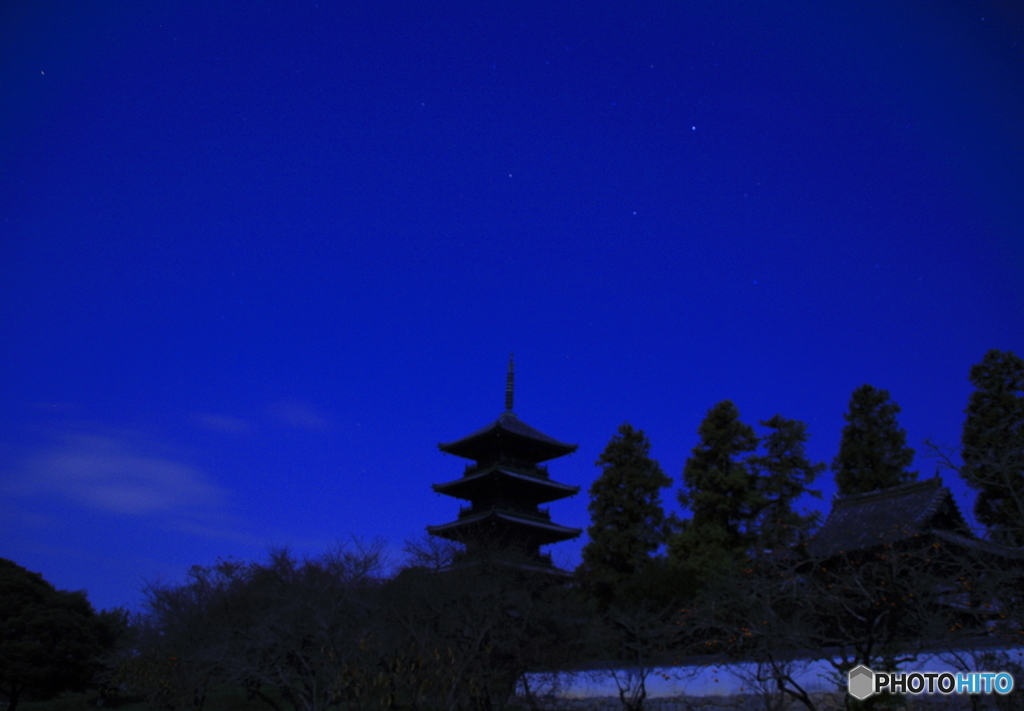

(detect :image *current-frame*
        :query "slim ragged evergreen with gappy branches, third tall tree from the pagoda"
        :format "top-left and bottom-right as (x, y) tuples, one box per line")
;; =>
(748, 415), (825, 550)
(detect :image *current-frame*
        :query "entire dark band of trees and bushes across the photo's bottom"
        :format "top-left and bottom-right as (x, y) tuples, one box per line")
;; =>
(0, 350), (1024, 711)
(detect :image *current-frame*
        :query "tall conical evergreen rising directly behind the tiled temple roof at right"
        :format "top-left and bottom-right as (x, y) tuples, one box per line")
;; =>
(833, 384), (918, 496)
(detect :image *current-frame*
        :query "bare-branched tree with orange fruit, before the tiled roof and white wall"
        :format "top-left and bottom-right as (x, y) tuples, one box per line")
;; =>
(679, 531), (1003, 711)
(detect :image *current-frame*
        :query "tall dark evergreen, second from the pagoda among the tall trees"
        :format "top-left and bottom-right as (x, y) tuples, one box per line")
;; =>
(670, 400), (763, 579)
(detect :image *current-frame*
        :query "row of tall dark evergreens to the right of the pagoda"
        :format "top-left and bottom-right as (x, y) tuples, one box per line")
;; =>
(577, 350), (1024, 599)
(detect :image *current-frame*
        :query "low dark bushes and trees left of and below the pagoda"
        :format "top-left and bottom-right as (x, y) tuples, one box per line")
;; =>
(0, 539), (599, 711)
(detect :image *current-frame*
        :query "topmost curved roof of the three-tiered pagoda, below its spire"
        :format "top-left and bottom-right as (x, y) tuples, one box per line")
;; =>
(437, 411), (578, 464)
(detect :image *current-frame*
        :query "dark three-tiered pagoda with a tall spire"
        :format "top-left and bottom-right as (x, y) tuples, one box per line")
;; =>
(427, 358), (583, 575)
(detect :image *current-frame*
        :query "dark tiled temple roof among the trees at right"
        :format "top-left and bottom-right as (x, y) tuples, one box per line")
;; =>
(807, 477), (970, 558)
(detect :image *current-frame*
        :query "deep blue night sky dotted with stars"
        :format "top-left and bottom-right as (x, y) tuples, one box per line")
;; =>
(0, 0), (1024, 609)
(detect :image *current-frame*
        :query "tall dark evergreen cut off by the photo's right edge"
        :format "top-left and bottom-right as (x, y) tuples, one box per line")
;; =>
(961, 350), (1024, 546)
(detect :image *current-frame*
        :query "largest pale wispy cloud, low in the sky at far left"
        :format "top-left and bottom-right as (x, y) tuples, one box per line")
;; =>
(5, 432), (226, 516)
